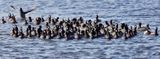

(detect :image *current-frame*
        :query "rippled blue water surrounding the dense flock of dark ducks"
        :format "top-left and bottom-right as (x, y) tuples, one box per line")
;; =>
(0, 0), (160, 59)
